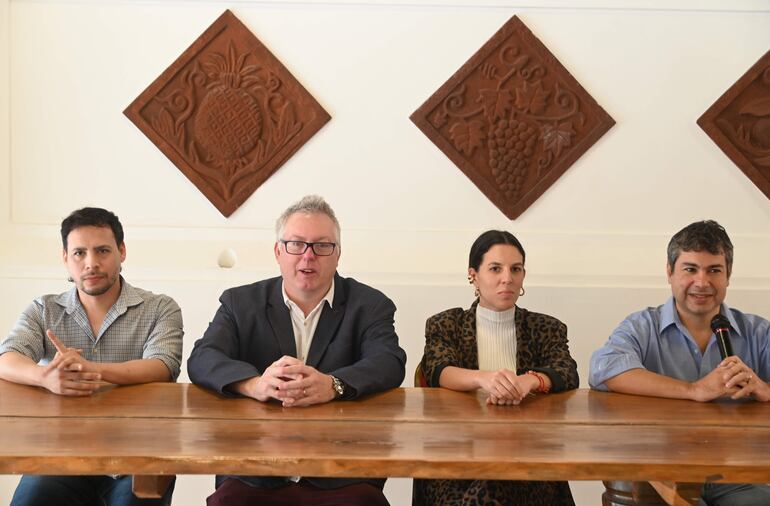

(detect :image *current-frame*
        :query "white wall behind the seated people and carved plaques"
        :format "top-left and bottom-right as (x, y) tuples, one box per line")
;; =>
(0, 0), (770, 505)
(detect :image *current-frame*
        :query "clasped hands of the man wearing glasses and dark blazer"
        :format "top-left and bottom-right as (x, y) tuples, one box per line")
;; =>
(241, 355), (334, 407)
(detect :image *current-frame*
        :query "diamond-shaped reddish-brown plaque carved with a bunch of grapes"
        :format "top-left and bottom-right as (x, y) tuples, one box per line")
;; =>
(411, 16), (615, 219)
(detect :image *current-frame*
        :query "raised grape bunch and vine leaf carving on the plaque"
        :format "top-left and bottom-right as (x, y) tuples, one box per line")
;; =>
(432, 44), (586, 200)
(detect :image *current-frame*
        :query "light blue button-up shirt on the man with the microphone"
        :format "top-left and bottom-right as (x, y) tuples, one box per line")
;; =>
(588, 297), (770, 391)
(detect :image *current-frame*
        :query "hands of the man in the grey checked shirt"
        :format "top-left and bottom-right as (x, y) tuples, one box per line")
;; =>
(42, 329), (103, 397)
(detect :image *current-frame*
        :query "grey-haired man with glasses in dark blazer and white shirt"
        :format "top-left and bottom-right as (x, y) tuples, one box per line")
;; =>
(187, 195), (406, 506)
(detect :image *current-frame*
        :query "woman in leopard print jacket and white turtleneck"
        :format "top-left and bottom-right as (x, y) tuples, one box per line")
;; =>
(412, 230), (578, 506)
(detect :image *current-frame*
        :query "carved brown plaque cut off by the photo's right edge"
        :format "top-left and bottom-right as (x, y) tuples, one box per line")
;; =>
(698, 51), (770, 199)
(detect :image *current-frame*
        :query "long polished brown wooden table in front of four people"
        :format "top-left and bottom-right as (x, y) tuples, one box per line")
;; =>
(0, 380), (770, 504)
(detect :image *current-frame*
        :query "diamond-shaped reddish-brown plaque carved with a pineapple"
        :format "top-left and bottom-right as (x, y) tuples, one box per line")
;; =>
(124, 10), (330, 216)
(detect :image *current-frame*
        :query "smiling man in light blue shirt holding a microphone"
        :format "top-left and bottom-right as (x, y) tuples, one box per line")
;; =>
(588, 220), (770, 506)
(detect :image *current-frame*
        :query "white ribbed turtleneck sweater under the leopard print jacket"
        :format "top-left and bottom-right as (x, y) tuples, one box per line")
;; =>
(476, 305), (516, 372)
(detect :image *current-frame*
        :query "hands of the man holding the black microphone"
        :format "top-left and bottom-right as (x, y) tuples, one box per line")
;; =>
(692, 356), (770, 402)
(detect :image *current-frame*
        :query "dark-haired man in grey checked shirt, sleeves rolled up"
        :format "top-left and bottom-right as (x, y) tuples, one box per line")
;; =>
(0, 207), (183, 506)
